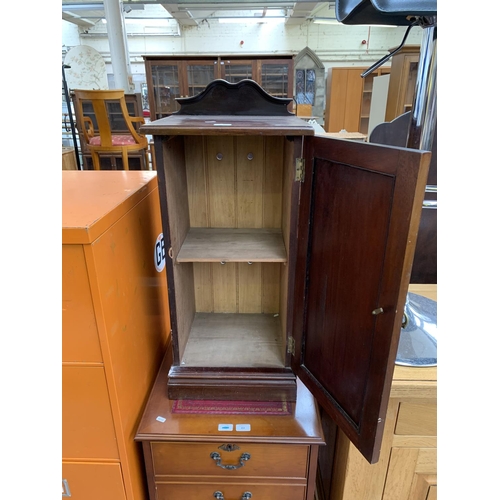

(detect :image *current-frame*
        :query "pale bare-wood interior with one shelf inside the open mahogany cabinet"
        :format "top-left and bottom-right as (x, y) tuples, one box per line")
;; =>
(163, 135), (295, 368)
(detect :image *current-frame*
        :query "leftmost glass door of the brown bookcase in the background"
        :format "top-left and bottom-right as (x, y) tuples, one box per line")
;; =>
(151, 63), (181, 119)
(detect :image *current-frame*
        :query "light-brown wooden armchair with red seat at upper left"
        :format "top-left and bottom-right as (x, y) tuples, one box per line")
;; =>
(73, 89), (149, 170)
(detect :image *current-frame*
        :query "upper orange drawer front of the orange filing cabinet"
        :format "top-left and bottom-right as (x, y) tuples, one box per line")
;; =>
(62, 245), (102, 363)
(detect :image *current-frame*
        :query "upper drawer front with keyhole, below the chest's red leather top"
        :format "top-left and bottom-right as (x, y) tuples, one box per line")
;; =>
(151, 443), (309, 478)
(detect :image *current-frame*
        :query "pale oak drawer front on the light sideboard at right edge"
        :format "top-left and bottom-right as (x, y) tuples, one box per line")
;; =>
(394, 402), (437, 436)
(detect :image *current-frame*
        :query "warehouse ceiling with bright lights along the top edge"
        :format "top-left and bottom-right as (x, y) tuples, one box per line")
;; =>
(62, 0), (334, 28)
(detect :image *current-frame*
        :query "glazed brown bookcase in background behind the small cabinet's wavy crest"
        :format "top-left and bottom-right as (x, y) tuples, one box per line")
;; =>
(143, 55), (293, 120)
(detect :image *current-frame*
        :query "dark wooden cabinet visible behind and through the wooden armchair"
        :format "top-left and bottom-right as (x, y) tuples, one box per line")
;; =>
(71, 93), (149, 170)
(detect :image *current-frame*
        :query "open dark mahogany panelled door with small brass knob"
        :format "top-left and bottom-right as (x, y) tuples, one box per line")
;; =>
(292, 137), (430, 463)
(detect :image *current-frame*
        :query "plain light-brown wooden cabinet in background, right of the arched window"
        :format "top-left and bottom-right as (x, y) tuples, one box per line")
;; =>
(324, 68), (391, 134)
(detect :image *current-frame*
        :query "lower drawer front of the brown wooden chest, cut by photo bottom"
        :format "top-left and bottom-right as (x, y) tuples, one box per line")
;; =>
(156, 481), (306, 500)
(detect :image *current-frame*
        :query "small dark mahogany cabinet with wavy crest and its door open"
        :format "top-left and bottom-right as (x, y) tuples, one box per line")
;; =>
(142, 80), (430, 461)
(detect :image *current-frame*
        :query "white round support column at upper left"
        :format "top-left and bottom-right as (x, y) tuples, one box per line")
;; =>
(104, 0), (135, 94)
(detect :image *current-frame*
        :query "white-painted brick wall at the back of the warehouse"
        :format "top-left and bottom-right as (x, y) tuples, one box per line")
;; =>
(62, 17), (422, 92)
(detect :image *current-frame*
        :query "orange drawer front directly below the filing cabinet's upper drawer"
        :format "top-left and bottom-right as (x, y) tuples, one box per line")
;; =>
(62, 366), (119, 459)
